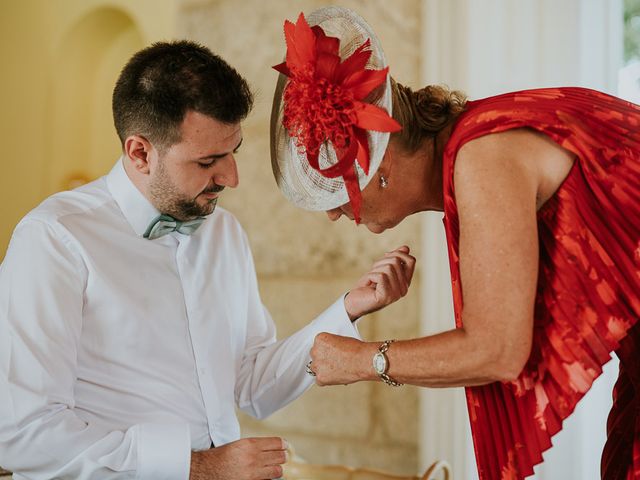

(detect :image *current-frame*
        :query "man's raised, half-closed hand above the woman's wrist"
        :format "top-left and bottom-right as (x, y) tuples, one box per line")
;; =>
(344, 245), (416, 321)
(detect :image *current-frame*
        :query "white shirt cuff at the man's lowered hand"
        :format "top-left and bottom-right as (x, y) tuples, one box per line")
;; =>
(137, 423), (191, 480)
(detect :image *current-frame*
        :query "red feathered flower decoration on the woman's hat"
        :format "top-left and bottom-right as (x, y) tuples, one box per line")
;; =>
(273, 13), (402, 223)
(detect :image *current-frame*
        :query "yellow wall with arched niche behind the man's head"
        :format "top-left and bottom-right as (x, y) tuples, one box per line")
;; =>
(0, 0), (178, 262)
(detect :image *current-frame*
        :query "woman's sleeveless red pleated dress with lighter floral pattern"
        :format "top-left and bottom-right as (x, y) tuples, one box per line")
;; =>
(443, 88), (640, 480)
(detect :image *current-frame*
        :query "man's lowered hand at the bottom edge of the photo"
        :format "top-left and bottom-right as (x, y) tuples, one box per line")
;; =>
(189, 437), (287, 480)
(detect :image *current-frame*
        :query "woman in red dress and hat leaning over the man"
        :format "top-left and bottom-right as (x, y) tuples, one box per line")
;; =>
(272, 7), (640, 480)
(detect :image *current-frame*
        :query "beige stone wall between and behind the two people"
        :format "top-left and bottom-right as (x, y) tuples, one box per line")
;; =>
(177, 0), (420, 473)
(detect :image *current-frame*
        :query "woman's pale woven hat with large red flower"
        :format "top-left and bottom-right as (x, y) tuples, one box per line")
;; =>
(271, 7), (401, 222)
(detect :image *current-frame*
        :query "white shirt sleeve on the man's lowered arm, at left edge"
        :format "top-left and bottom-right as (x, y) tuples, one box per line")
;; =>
(0, 219), (191, 480)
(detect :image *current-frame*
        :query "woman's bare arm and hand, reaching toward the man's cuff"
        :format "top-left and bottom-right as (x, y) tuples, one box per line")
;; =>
(312, 131), (549, 387)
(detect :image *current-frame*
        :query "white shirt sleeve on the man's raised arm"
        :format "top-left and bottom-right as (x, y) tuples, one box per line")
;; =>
(236, 234), (361, 418)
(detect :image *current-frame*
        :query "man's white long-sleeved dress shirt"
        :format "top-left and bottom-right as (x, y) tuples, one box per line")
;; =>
(0, 161), (358, 480)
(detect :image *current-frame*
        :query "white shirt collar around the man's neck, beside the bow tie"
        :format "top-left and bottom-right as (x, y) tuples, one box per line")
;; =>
(107, 157), (160, 236)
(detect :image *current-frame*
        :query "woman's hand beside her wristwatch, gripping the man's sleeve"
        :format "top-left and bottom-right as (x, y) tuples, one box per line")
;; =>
(310, 333), (376, 386)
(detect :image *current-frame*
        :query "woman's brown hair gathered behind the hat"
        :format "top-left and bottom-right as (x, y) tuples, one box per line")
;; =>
(391, 78), (467, 153)
